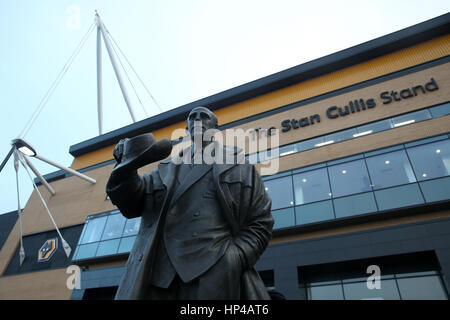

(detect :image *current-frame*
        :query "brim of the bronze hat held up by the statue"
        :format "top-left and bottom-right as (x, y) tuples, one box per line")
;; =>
(112, 138), (172, 174)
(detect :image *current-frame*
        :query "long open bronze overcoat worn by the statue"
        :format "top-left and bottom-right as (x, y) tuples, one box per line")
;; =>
(106, 146), (273, 299)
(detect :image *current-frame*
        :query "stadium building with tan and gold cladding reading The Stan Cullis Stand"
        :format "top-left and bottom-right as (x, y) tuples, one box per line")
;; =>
(0, 14), (450, 300)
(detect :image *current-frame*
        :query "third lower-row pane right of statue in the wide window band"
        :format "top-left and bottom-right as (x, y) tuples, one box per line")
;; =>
(333, 192), (377, 218)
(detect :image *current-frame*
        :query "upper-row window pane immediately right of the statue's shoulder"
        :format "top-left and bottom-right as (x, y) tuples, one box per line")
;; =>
(264, 176), (294, 210)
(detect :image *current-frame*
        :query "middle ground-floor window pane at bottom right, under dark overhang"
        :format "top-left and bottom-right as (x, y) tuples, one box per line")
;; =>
(344, 280), (400, 300)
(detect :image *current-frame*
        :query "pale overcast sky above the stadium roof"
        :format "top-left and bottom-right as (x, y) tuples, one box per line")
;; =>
(0, 0), (450, 214)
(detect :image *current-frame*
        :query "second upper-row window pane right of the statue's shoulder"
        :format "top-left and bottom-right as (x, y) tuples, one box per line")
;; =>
(294, 168), (331, 205)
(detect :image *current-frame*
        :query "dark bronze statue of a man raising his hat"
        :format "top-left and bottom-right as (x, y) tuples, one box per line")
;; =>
(106, 107), (274, 300)
